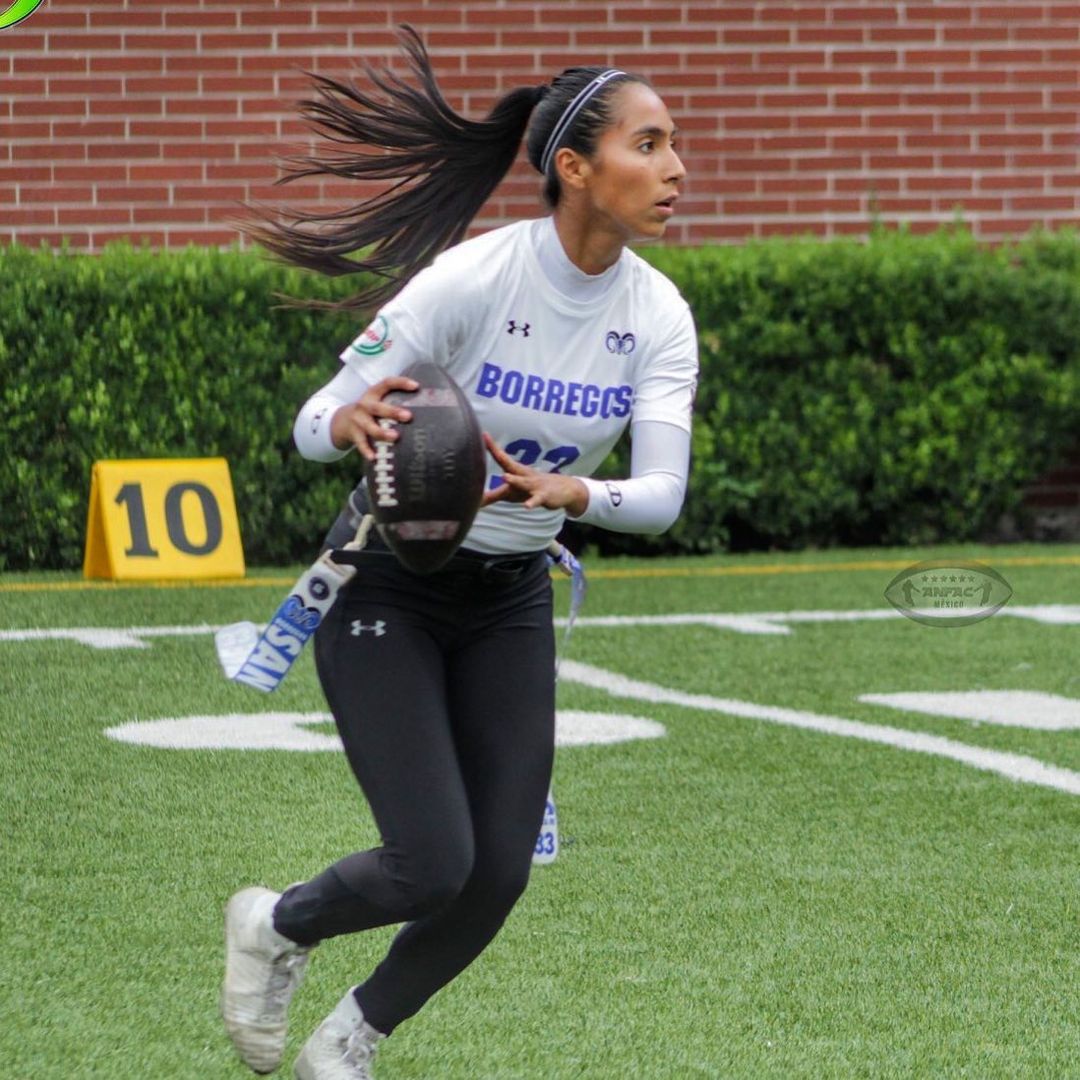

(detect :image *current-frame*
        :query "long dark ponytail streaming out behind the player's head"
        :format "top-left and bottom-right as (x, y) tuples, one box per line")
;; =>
(244, 26), (548, 309)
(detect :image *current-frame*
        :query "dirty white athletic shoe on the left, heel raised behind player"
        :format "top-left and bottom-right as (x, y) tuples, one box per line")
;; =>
(221, 887), (311, 1072)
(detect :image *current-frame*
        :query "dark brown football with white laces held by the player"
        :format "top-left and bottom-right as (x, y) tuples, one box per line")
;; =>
(364, 361), (486, 573)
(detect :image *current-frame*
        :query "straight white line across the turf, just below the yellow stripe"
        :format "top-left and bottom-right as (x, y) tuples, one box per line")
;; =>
(0, 604), (1080, 649)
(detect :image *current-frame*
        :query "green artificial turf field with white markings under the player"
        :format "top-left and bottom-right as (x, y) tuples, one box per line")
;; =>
(0, 545), (1080, 1080)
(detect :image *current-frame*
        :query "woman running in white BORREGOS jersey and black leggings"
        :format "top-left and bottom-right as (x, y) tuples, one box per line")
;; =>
(222, 27), (697, 1080)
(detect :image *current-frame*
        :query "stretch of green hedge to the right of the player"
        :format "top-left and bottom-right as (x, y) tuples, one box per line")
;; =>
(617, 229), (1080, 551)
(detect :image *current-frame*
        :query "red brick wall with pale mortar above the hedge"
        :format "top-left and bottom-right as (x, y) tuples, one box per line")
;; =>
(6, 0), (1080, 248)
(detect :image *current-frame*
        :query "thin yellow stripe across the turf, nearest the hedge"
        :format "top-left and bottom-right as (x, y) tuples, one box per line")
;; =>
(0, 555), (1080, 593)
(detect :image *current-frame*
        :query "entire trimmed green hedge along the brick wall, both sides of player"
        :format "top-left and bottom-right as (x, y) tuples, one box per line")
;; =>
(0, 229), (1080, 569)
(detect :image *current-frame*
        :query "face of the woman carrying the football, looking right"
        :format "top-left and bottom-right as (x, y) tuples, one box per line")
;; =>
(585, 82), (686, 241)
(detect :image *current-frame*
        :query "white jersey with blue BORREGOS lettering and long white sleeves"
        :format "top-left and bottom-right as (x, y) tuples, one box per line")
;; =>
(294, 218), (698, 553)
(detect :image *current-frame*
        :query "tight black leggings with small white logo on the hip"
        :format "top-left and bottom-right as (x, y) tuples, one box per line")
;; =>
(274, 551), (555, 1034)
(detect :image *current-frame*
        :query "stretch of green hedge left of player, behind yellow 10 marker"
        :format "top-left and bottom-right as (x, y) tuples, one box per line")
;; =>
(0, 245), (357, 569)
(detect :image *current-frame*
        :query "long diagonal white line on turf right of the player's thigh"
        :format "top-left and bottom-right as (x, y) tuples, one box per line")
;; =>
(559, 660), (1080, 795)
